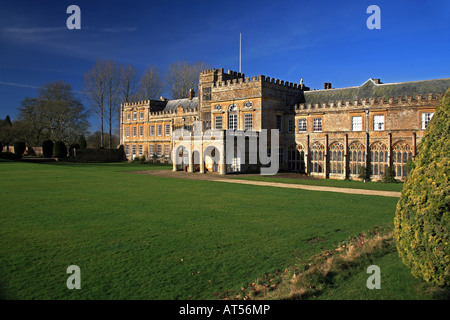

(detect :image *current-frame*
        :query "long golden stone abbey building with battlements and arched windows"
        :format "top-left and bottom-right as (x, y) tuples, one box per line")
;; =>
(120, 69), (450, 180)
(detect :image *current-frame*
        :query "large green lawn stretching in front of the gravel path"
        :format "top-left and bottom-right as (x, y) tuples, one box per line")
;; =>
(0, 161), (438, 300)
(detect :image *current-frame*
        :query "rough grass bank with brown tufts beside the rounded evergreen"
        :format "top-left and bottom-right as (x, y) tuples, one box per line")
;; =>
(225, 229), (450, 300)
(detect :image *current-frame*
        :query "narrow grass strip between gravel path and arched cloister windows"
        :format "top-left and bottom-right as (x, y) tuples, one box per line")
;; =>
(229, 174), (403, 191)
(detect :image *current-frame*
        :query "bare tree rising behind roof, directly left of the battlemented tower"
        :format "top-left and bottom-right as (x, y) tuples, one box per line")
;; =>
(165, 61), (210, 99)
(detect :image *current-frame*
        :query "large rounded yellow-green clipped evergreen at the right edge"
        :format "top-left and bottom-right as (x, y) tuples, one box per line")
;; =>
(394, 89), (450, 286)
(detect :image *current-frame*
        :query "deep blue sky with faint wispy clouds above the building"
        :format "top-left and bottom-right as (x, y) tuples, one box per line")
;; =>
(0, 0), (450, 130)
